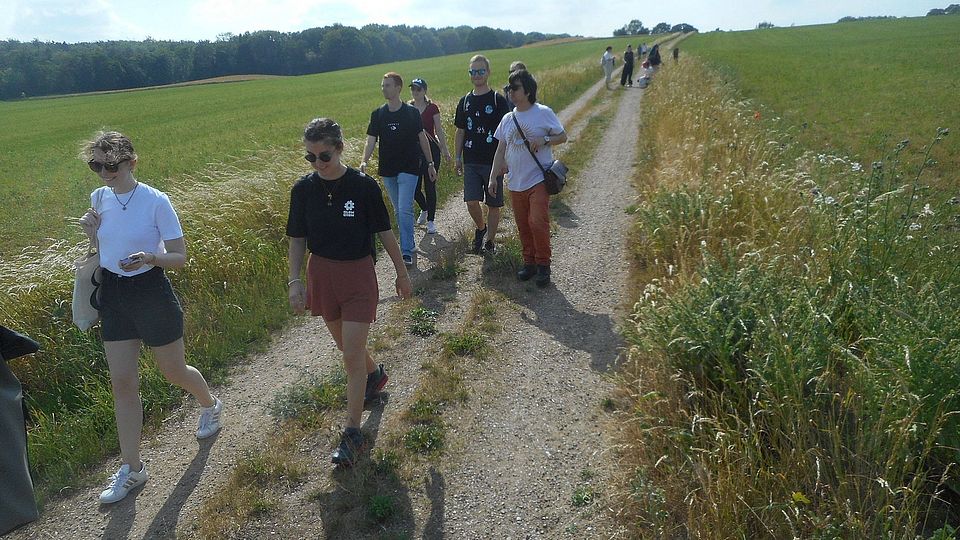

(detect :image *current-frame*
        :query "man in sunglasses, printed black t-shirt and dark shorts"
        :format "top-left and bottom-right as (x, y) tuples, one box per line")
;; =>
(453, 54), (509, 254)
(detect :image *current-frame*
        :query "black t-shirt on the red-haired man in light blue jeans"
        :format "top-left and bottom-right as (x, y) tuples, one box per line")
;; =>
(367, 103), (423, 176)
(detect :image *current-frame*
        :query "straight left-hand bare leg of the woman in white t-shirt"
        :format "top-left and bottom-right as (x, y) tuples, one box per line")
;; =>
(103, 339), (143, 471)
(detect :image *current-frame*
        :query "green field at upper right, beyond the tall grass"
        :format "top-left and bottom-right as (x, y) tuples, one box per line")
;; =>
(680, 17), (960, 183)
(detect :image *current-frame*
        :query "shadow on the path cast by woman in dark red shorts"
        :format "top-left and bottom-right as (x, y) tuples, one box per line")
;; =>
(311, 393), (415, 538)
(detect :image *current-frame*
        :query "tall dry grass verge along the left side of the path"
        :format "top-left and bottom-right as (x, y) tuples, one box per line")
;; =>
(0, 44), (616, 501)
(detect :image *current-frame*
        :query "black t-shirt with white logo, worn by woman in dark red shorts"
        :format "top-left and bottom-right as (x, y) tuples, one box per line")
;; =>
(287, 167), (390, 261)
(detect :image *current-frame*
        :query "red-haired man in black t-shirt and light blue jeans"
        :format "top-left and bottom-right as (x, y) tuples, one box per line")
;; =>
(360, 71), (437, 266)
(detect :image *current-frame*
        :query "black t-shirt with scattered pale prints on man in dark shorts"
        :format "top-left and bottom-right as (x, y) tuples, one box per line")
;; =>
(453, 90), (510, 165)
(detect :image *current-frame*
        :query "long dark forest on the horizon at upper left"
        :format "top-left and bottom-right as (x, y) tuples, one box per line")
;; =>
(0, 24), (569, 100)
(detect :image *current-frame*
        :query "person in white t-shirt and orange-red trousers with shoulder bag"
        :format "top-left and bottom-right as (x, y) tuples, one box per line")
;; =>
(489, 69), (567, 287)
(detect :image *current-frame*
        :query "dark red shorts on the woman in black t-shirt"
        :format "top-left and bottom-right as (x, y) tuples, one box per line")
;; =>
(307, 254), (380, 323)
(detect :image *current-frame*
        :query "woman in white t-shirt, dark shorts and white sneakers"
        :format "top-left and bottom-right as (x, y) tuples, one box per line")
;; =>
(80, 131), (223, 503)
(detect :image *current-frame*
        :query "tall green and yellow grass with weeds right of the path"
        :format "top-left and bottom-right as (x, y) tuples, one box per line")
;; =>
(622, 57), (960, 538)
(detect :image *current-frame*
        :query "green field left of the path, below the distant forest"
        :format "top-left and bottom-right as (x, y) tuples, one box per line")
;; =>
(0, 39), (627, 261)
